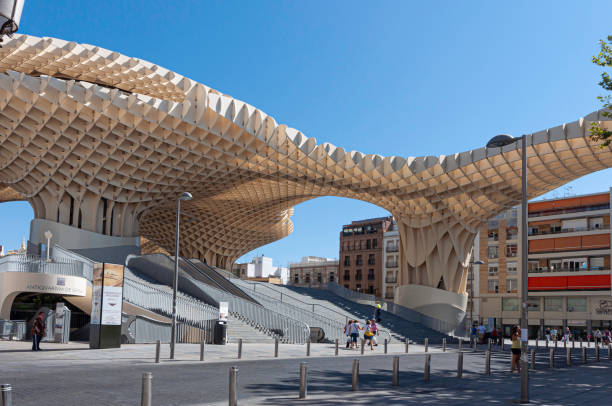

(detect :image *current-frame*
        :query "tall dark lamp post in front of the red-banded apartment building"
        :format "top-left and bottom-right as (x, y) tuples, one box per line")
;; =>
(487, 134), (529, 403)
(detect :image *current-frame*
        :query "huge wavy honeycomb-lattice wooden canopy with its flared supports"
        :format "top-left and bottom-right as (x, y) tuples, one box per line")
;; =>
(0, 35), (612, 316)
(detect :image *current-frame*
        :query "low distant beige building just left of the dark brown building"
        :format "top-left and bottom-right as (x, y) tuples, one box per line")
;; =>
(289, 256), (340, 288)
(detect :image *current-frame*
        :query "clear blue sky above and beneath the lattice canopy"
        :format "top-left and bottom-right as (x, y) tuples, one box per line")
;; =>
(0, 0), (612, 265)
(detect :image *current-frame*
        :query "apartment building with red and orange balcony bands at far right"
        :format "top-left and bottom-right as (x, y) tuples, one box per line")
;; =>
(476, 192), (612, 337)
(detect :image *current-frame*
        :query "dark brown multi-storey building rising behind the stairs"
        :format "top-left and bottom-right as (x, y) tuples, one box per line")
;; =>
(339, 217), (393, 296)
